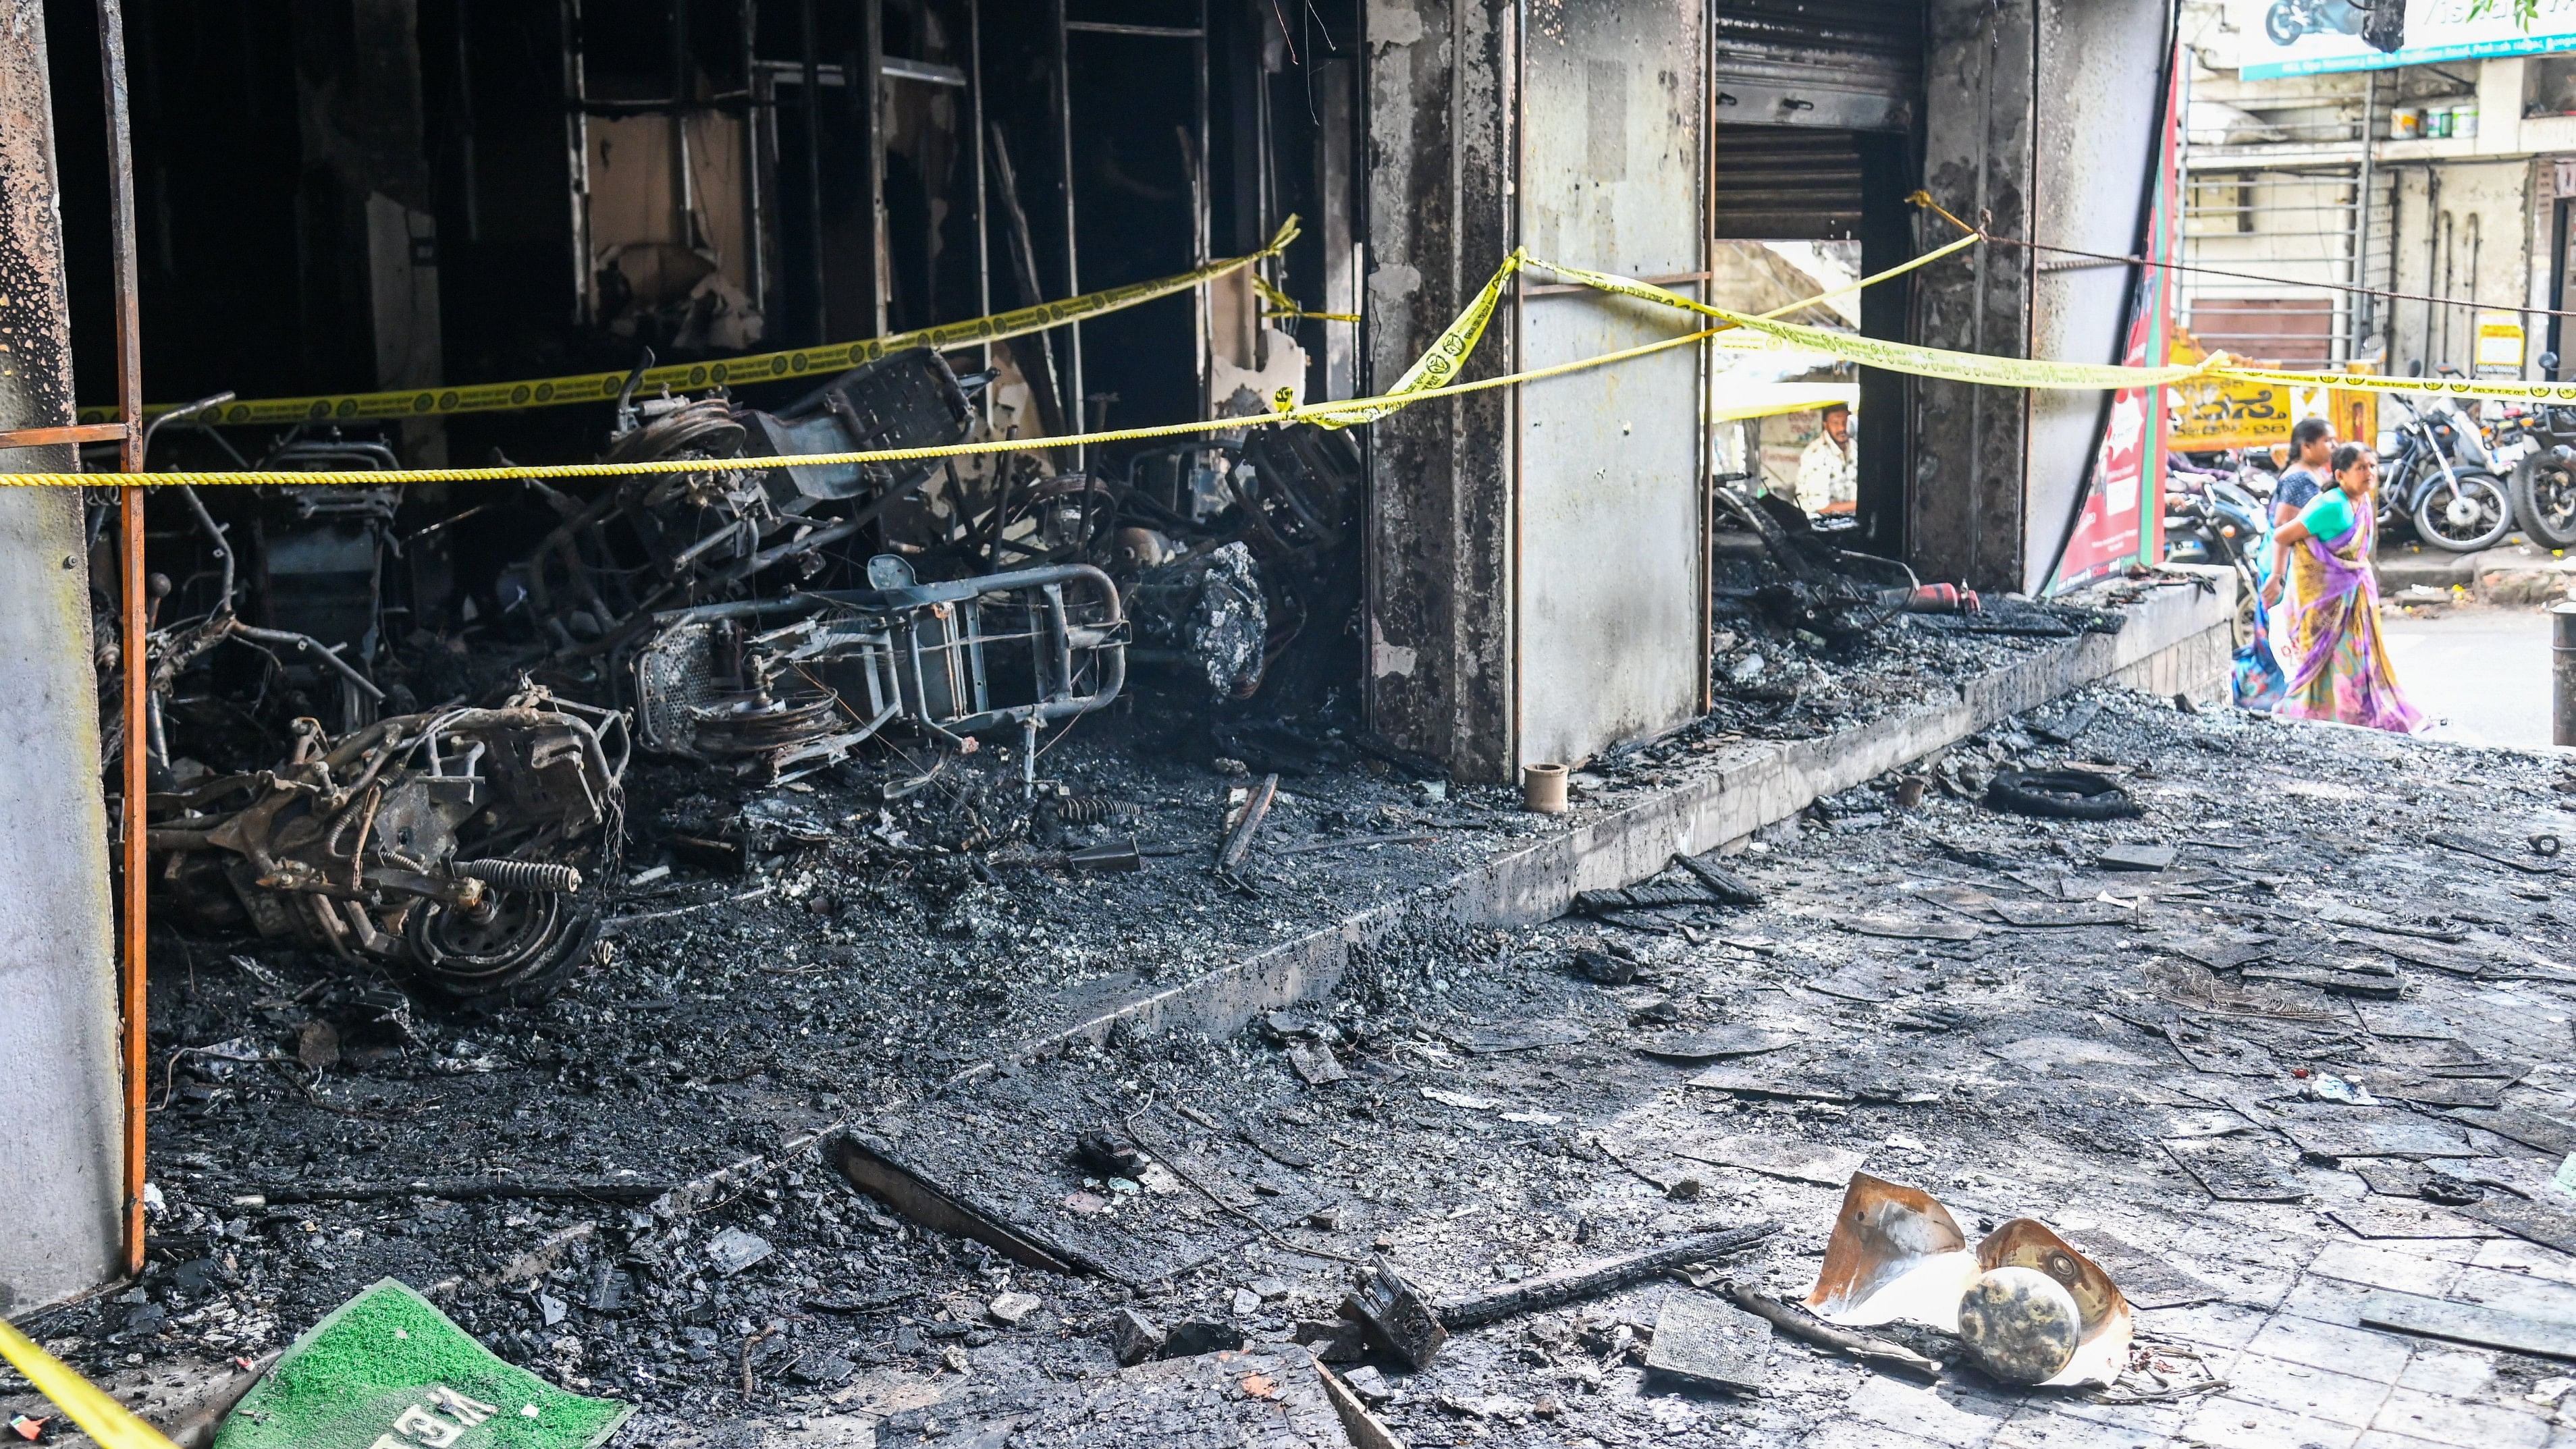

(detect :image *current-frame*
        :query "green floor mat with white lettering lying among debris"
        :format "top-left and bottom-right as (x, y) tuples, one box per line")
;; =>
(214, 1279), (634, 1449)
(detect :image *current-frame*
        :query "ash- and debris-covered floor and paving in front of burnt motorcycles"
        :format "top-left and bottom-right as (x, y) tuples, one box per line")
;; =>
(34, 607), (2576, 1446)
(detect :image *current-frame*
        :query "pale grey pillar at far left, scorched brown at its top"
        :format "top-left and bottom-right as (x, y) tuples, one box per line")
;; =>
(0, 0), (124, 1313)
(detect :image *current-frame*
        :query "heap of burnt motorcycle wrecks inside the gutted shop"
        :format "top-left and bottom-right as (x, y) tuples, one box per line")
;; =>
(111, 350), (1383, 1001)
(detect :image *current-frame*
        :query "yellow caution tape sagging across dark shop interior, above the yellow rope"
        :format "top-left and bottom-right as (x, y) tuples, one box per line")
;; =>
(80, 216), (1298, 425)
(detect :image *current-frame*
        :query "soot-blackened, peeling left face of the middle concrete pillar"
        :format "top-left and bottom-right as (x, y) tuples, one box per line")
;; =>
(1363, 0), (1520, 780)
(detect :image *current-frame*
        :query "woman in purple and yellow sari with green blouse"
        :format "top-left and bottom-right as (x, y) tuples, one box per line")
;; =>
(2264, 443), (2424, 734)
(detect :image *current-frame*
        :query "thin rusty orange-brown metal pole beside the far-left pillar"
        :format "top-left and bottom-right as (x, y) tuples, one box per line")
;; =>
(98, 0), (152, 1274)
